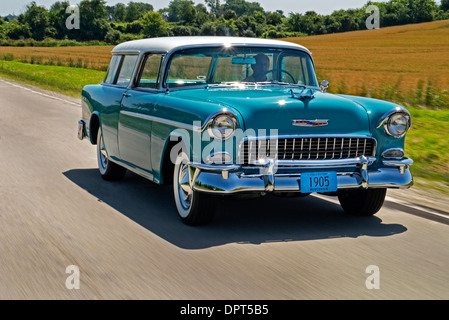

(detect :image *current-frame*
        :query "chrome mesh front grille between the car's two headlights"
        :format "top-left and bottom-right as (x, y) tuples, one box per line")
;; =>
(239, 137), (376, 165)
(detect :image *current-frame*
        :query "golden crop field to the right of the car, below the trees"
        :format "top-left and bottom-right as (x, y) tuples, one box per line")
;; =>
(284, 20), (449, 108)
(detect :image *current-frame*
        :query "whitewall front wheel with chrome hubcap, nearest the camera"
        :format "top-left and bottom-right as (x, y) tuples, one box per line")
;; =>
(173, 152), (215, 226)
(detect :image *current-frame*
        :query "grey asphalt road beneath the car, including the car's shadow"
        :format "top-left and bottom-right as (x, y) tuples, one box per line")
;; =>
(0, 79), (449, 300)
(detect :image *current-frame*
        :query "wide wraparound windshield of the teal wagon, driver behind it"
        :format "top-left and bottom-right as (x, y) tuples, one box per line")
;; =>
(165, 47), (318, 88)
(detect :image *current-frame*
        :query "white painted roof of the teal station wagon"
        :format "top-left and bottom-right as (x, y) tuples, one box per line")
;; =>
(112, 36), (311, 54)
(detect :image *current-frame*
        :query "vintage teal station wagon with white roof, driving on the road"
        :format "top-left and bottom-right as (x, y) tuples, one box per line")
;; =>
(78, 37), (413, 225)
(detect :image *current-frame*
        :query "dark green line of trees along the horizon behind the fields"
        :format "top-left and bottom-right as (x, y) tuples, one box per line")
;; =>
(0, 0), (449, 44)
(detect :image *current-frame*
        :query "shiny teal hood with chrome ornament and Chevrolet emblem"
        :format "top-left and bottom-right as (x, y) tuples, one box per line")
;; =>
(173, 86), (370, 135)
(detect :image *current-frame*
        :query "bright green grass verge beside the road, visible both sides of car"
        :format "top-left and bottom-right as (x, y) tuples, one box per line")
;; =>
(0, 61), (449, 193)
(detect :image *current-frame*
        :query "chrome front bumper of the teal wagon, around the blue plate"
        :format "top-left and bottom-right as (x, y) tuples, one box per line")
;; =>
(184, 157), (413, 194)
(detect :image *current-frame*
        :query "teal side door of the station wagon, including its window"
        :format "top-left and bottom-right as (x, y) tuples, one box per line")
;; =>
(118, 53), (163, 176)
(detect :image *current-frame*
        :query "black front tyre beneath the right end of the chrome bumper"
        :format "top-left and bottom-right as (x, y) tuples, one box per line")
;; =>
(338, 188), (387, 216)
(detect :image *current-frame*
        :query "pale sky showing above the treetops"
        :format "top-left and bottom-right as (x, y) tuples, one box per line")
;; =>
(0, 0), (440, 16)
